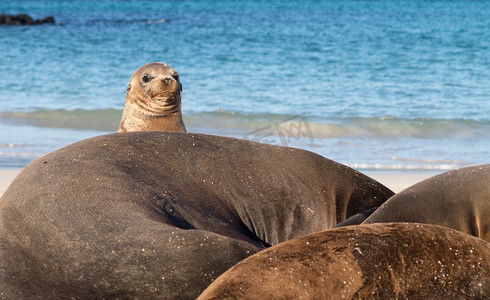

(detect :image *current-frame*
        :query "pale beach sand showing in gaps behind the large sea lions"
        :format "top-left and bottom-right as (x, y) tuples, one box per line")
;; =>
(0, 169), (437, 196)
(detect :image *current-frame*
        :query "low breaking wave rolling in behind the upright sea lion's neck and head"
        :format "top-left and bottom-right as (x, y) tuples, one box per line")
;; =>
(0, 108), (490, 139)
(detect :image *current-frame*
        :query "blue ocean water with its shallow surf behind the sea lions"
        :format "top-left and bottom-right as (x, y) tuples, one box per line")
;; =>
(0, 0), (490, 171)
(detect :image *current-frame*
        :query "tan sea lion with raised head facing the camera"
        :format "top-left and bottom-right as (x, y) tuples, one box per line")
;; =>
(118, 63), (186, 132)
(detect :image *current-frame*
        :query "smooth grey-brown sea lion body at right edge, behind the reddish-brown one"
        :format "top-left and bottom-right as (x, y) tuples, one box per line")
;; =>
(363, 165), (490, 242)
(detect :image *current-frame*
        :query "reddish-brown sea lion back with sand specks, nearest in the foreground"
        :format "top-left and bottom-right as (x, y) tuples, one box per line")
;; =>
(197, 223), (490, 300)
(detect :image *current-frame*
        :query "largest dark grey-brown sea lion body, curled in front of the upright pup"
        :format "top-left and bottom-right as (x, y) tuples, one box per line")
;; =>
(0, 132), (393, 299)
